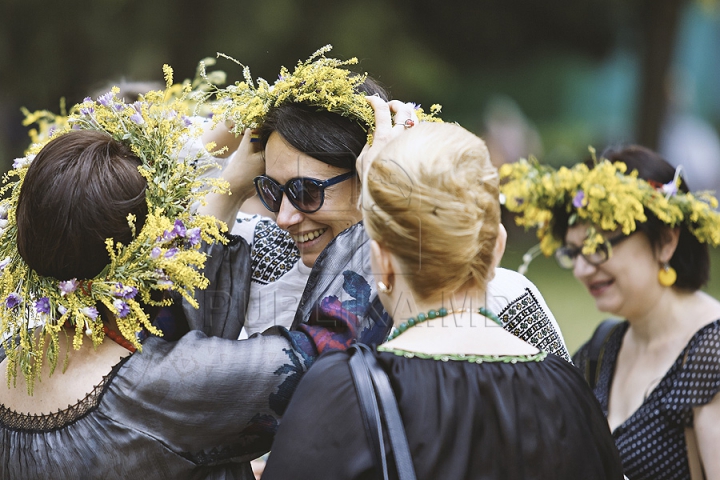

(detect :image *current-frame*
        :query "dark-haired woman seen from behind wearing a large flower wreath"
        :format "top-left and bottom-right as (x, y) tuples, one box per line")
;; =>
(0, 87), (352, 480)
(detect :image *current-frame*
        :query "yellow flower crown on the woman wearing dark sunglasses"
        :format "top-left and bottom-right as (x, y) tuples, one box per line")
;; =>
(200, 45), (441, 140)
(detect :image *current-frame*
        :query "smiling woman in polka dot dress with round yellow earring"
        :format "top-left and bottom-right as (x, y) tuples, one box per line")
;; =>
(501, 146), (720, 480)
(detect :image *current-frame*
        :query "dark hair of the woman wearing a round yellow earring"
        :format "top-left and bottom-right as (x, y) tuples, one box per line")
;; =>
(553, 145), (710, 291)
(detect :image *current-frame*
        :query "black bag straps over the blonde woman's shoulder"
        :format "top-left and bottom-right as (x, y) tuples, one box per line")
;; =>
(350, 345), (416, 480)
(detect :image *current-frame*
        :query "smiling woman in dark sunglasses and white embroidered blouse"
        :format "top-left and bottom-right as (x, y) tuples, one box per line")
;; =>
(199, 48), (570, 360)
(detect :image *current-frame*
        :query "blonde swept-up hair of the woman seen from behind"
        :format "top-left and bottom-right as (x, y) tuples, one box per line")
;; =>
(362, 123), (500, 298)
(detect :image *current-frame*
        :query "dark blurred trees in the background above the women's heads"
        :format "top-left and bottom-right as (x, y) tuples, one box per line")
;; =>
(0, 0), (716, 170)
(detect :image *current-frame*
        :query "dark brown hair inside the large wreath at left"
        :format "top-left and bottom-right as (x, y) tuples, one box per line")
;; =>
(17, 130), (147, 280)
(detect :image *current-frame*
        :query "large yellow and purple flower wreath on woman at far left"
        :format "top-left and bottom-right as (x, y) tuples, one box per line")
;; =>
(0, 65), (226, 394)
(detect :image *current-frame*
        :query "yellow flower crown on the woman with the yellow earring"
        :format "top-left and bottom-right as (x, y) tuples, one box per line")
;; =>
(500, 149), (720, 256)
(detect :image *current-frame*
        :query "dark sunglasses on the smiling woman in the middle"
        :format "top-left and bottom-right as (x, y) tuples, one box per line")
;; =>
(254, 172), (355, 213)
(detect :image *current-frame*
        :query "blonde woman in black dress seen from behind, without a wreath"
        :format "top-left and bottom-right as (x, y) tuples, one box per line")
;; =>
(263, 118), (622, 480)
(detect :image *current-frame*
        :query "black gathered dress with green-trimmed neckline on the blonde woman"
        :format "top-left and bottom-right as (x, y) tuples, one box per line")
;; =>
(263, 347), (622, 480)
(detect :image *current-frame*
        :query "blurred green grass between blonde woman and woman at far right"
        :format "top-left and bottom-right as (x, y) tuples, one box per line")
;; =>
(501, 238), (720, 353)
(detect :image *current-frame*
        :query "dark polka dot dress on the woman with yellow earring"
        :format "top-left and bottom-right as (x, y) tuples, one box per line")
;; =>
(573, 320), (720, 480)
